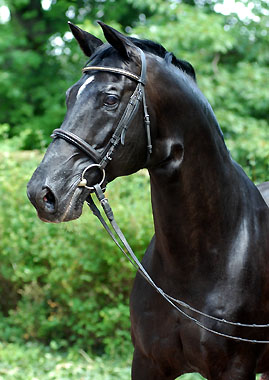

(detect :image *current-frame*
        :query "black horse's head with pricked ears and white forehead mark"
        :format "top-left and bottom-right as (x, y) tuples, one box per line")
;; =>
(28, 22), (164, 222)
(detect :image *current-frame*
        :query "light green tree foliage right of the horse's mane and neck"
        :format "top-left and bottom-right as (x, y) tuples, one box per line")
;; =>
(134, 1), (269, 182)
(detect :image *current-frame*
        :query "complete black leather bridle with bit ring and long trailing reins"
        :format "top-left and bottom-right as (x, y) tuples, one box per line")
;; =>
(51, 48), (269, 344)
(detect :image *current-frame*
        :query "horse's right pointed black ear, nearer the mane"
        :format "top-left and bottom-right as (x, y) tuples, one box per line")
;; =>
(97, 21), (137, 60)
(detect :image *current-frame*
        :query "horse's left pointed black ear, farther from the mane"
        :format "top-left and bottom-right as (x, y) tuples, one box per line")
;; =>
(68, 21), (103, 57)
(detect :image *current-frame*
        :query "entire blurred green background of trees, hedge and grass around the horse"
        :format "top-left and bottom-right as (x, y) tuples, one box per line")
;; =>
(0, 0), (269, 380)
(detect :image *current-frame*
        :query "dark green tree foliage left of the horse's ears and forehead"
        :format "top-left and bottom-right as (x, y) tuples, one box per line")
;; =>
(0, 0), (153, 149)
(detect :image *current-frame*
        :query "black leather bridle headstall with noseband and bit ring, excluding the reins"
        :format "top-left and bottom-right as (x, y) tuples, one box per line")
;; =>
(51, 48), (152, 190)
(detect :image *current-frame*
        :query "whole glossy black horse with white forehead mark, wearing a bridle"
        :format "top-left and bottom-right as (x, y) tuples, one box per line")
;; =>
(28, 23), (269, 380)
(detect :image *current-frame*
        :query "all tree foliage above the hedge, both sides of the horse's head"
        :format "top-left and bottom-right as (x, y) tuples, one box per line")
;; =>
(0, 0), (269, 182)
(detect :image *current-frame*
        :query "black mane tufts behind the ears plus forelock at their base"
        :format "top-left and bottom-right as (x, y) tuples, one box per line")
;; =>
(87, 37), (196, 80)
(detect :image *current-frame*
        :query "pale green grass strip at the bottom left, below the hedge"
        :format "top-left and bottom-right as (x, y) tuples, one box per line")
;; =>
(0, 343), (131, 380)
